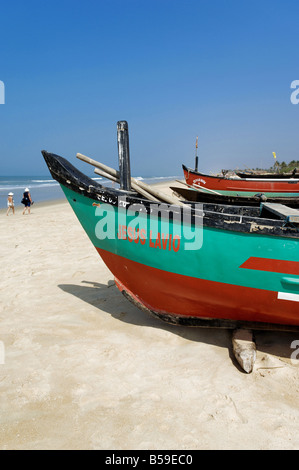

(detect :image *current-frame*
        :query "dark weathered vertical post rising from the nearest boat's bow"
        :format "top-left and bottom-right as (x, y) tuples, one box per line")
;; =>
(117, 121), (131, 191)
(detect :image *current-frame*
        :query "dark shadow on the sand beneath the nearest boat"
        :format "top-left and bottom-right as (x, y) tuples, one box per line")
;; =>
(58, 280), (299, 372)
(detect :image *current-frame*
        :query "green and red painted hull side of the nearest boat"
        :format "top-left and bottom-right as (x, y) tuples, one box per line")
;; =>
(63, 182), (299, 327)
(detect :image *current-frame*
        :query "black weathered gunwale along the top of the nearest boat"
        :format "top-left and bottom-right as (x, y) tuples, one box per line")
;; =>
(42, 150), (299, 238)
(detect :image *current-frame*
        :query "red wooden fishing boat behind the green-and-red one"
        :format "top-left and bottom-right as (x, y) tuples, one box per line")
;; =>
(183, 165), (299, 198)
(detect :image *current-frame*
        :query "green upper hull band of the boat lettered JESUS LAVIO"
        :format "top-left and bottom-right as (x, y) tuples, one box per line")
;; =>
(62, 187), (299, 293)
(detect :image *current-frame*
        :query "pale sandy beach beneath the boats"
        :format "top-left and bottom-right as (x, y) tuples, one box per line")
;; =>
(0, 185), (299, 450)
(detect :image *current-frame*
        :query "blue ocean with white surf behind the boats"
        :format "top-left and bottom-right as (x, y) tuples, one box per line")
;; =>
(0, 175), (181, 209)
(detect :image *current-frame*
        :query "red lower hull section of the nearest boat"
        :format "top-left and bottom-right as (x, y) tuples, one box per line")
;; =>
(97, 248), (299, 325)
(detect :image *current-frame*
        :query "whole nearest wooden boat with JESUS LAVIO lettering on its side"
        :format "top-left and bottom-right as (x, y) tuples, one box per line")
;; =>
(42, 129), (299, 330)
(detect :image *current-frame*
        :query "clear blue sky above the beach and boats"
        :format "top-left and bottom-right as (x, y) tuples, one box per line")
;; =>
(0, 0), (299, 176)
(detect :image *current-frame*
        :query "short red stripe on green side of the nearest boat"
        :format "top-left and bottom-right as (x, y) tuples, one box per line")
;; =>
(240, 256), (299, 276)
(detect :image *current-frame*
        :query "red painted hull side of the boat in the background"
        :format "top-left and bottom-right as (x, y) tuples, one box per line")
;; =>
(183, 167), (299, 193)
